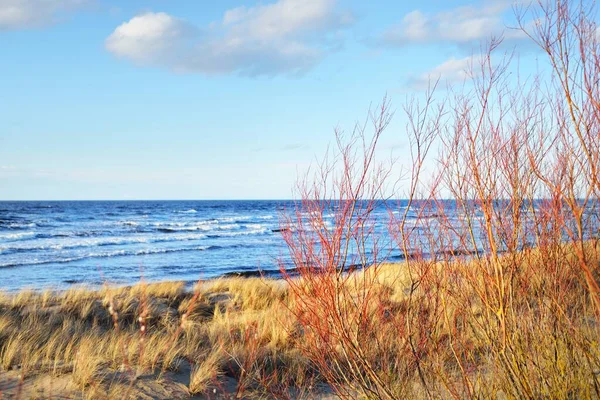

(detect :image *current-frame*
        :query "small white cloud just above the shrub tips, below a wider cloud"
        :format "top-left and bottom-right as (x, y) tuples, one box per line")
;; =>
(409, 55), (482, 90)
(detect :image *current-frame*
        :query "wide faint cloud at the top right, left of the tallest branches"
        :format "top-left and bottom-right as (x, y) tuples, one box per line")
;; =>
(381, 0), (524, 46)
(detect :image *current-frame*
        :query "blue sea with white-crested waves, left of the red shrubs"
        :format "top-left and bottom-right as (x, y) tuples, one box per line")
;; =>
(0, 201), (300, 290)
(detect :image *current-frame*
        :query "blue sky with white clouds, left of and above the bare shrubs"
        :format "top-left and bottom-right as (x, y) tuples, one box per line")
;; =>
(0, 0), (537, 200)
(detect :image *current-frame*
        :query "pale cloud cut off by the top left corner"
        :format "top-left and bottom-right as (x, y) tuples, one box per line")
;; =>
(0, 0), (87, 31)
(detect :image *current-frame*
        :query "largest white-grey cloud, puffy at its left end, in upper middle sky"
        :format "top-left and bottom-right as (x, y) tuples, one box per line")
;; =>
(106, 0), (352, 75)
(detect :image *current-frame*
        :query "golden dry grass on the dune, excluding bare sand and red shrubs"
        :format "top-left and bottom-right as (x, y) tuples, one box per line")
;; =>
(0, 249), (600, 398)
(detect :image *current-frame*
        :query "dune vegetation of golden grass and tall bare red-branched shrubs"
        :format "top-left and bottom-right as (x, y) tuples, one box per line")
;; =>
(0, 0), (600, 399)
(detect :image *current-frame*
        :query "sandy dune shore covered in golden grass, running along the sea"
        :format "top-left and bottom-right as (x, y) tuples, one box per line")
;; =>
(0, 242), (598, 400)
